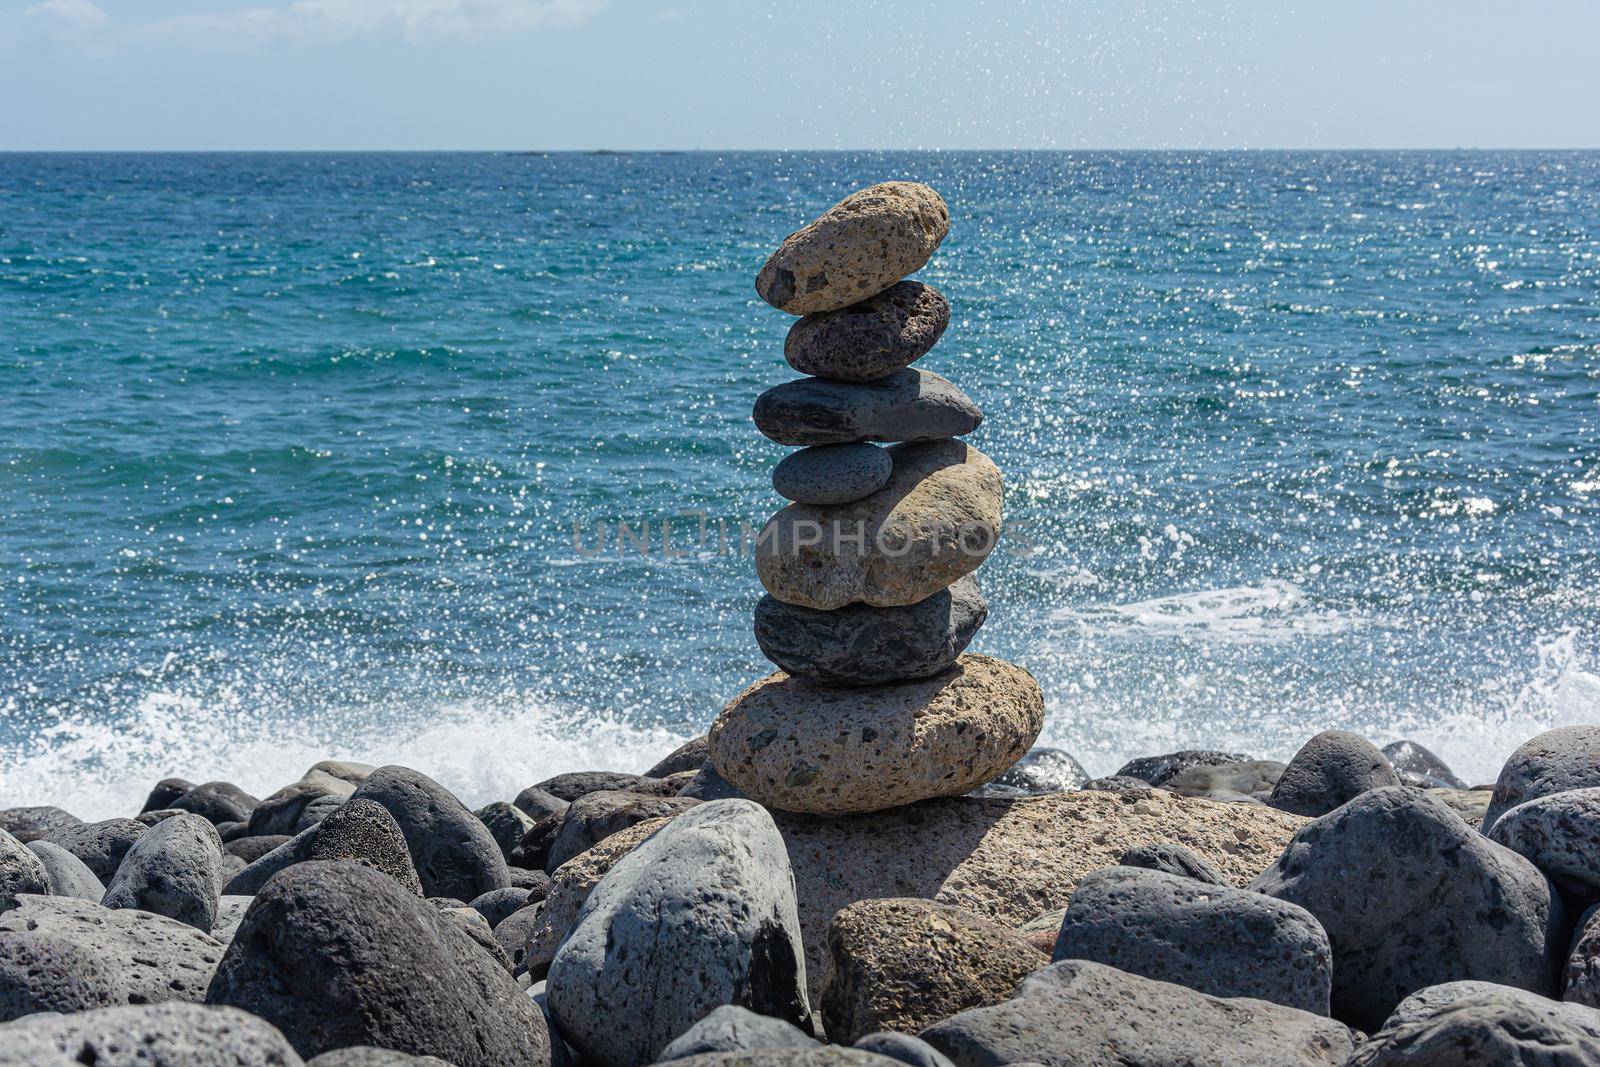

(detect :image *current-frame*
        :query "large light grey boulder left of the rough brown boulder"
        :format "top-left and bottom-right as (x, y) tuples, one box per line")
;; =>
(547, 800), (811, 1067)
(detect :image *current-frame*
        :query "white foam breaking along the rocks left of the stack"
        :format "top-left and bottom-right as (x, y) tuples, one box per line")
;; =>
(0, 691), (686, 819)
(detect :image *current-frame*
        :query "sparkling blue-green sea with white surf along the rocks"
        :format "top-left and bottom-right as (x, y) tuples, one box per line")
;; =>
(0, 152), (1600, 816)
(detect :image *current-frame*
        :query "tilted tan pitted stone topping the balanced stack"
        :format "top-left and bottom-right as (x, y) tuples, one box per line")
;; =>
(755, 181), (950, 315)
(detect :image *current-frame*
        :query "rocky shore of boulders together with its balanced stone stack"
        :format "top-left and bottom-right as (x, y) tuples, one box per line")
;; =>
(9, 182), (1600, 1067)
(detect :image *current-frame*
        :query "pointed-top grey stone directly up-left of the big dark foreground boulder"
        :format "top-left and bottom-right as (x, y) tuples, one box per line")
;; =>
(101, 813), (222, 931)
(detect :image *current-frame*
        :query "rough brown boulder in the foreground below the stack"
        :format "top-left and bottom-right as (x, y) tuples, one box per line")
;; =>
(821, 897), (1050, 1043)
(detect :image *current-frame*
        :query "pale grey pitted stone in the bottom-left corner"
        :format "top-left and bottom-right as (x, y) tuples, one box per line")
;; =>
(0, 1005), (302, 1067)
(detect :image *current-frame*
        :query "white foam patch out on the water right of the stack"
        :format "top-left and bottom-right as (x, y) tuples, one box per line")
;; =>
(1051, 579), (1360, 645)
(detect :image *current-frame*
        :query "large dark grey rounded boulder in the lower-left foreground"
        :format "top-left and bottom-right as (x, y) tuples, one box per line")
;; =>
(206, 863), (550, 1067)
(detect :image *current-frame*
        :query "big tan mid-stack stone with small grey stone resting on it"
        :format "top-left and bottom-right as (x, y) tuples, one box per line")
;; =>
(755, 440), (1005, 607)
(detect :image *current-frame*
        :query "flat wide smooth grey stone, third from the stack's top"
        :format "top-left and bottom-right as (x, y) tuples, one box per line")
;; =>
(750, 366), (984, 445)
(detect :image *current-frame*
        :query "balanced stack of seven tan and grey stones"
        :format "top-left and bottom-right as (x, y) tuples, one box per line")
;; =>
(710, 182), (1045, 816)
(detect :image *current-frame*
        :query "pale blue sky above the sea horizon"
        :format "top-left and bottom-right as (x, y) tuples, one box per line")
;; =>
(0, 0), (1600, 150)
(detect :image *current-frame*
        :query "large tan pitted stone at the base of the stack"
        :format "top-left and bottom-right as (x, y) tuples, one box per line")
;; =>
(710, 656), (1045, 816)
